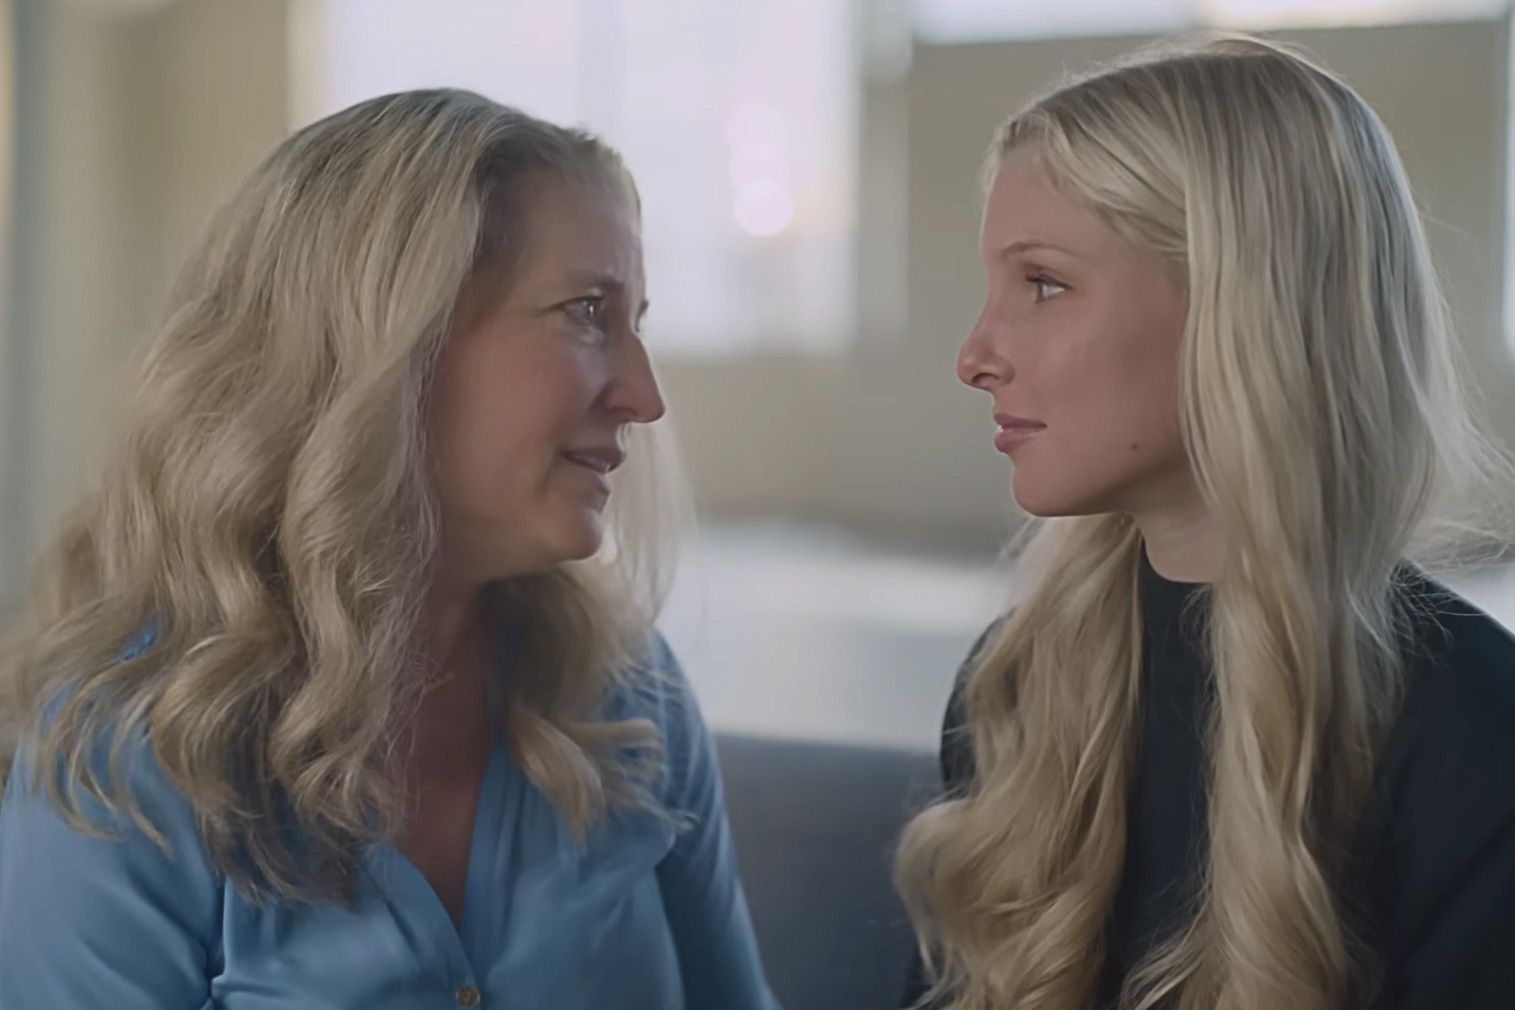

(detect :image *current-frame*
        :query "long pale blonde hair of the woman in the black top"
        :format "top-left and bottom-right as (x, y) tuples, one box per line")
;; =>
(897, 36), (1507, 1010)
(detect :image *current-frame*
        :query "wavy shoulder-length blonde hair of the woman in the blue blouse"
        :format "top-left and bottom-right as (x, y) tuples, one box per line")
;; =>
(0, 89), (682, 899)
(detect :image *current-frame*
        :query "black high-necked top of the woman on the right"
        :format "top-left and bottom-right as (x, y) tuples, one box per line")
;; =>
(907, 560), (1515, 1010)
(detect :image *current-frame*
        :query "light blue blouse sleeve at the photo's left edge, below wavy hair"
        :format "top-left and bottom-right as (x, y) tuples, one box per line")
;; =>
(0, 675), (226, 1007)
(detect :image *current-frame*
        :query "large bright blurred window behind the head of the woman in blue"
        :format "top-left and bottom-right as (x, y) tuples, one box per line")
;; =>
(291, 0), (859, 353)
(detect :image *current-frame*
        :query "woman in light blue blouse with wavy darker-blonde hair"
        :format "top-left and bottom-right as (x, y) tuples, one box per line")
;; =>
(0, 91), (776, 1010)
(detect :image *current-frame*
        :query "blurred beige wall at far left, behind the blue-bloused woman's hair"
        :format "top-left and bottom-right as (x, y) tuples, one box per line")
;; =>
(0, 0), (288, 595)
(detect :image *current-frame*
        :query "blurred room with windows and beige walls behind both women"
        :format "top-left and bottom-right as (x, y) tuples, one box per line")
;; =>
(0, 0), (1515, 751)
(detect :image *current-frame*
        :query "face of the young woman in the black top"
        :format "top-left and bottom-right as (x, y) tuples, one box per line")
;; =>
(957, 150), (1192, 516)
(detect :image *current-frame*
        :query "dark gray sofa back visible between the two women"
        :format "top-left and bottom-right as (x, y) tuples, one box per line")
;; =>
(717, 734), (938, 1010)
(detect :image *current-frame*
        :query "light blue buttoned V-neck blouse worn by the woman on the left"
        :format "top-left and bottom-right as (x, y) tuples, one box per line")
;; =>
(0, 641), (777, 1010)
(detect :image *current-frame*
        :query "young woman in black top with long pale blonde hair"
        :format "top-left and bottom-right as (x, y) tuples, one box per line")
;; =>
(898, 39), (1515, 1010)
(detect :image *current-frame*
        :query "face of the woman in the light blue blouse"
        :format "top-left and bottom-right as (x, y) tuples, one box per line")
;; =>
(429, 172), (664, 584)
